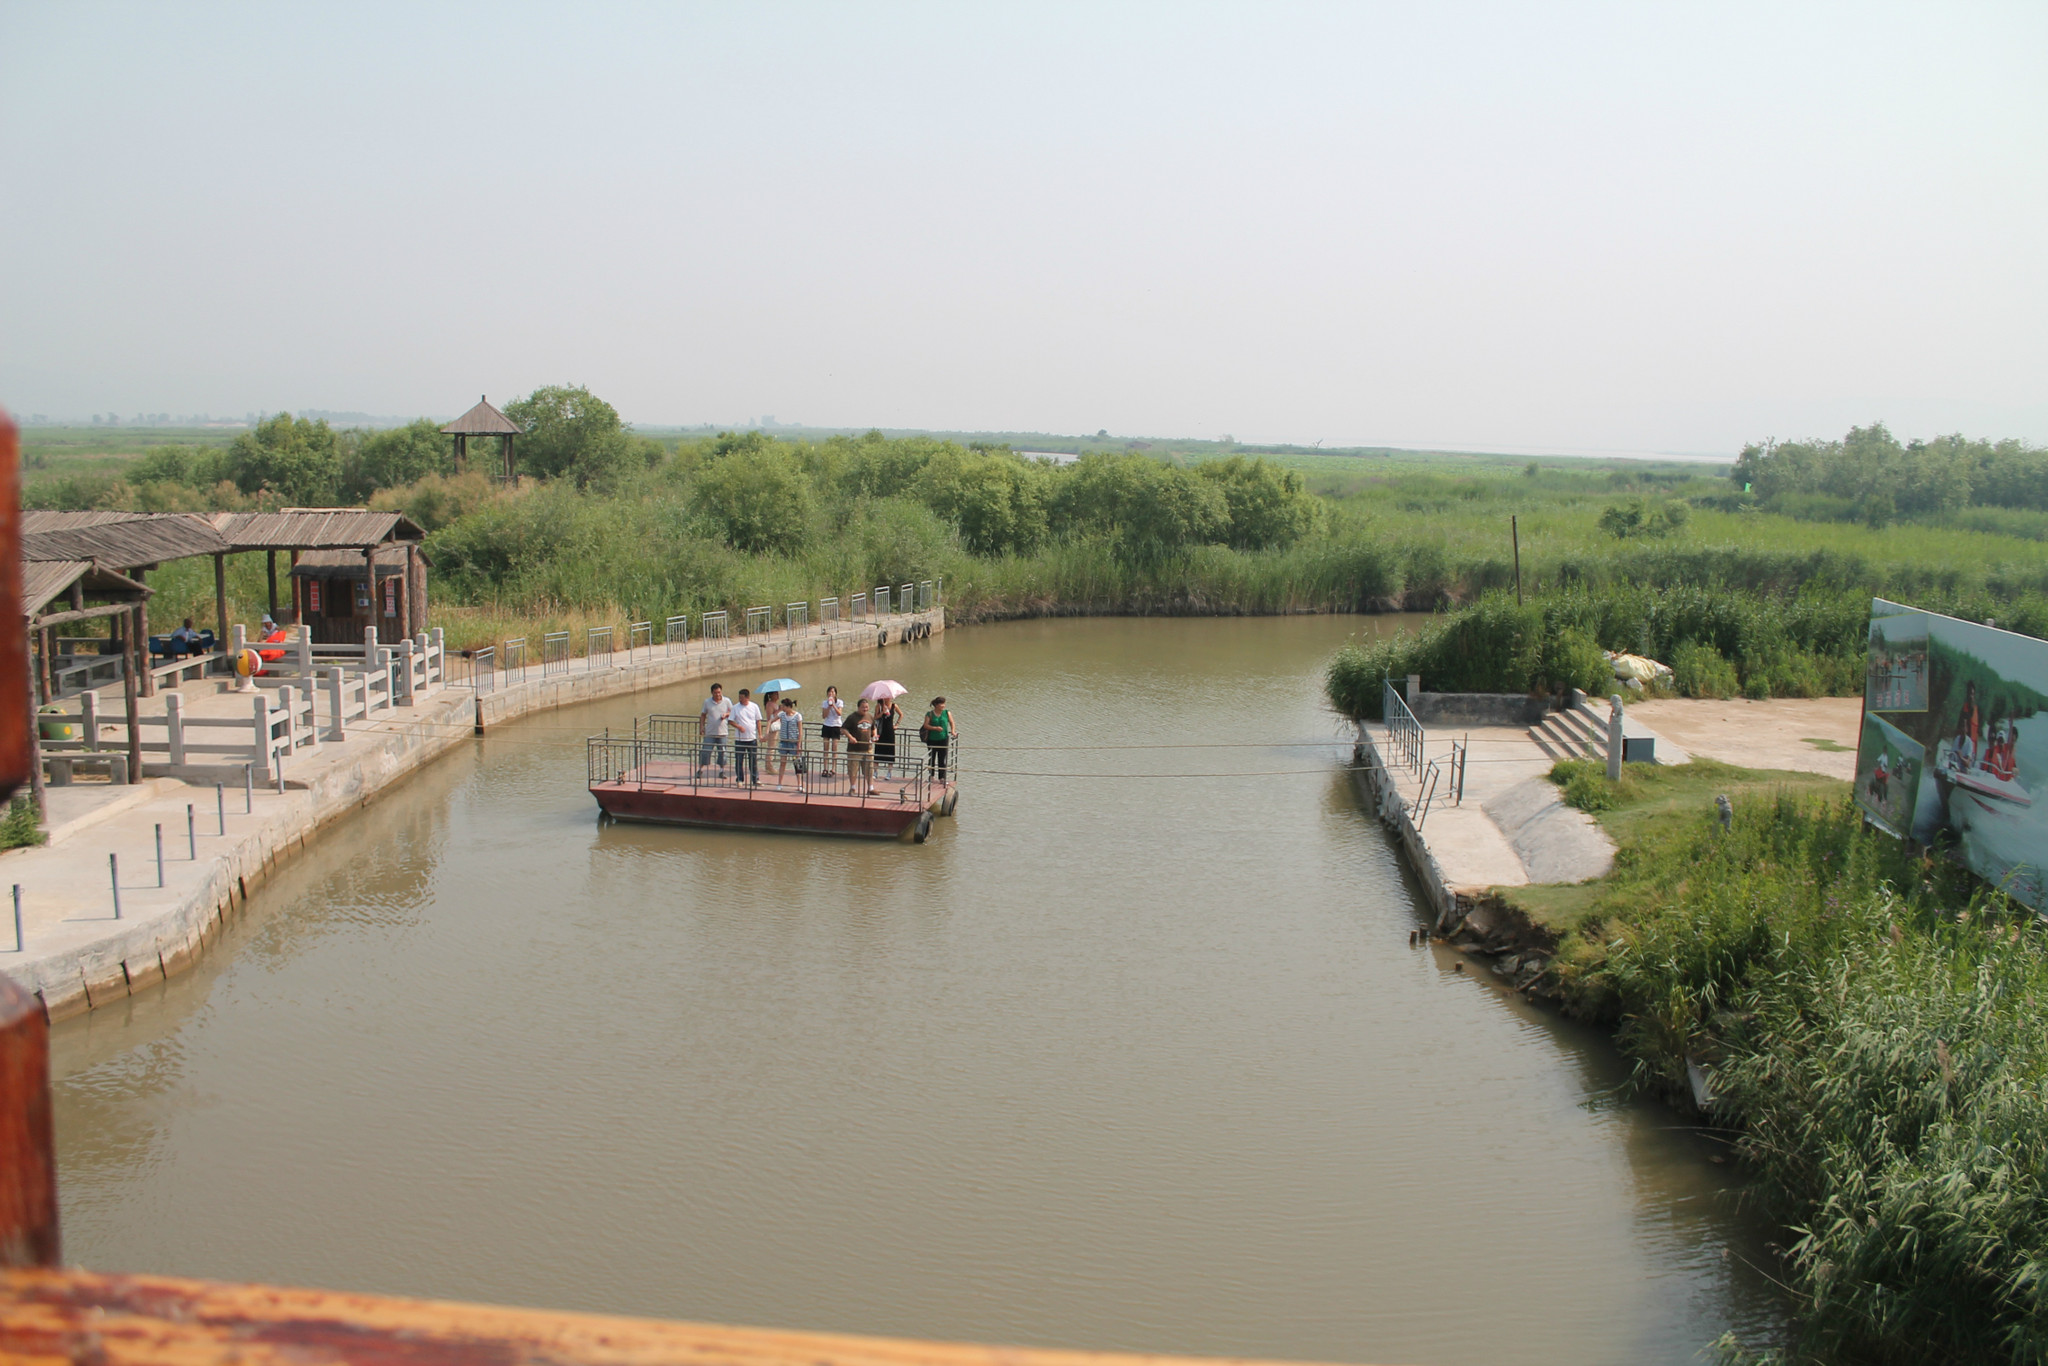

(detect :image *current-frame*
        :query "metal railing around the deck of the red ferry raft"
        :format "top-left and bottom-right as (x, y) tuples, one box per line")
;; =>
(586, 715), (961, 807)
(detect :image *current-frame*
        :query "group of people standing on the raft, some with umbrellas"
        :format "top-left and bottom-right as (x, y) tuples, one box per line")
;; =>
(696, 680), (958, 797)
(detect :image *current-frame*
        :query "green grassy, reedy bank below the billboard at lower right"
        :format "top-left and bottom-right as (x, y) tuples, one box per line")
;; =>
(1511, 760), (2048, 1364)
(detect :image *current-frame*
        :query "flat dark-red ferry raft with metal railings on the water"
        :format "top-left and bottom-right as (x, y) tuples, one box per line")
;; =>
(586, 715), (961, 844)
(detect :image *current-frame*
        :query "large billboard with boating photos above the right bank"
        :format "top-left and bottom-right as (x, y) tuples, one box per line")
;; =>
(1855, 598), (2048, 909)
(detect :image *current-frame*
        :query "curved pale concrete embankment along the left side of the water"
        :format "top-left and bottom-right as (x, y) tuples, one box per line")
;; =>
(0, 608), (946, 1020)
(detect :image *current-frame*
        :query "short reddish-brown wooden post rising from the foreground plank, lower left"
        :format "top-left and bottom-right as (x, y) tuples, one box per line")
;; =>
(0, 977), (59, 1268)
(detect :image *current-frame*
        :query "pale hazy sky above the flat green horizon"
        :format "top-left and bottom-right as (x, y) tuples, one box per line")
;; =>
(0, 0), (2048, 455)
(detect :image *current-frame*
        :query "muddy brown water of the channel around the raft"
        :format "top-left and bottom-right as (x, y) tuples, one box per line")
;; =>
(55, 616), (1784, 1366)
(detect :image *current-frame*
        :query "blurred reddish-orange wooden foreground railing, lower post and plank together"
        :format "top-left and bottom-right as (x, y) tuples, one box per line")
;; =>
(0, 977), (1392, 1366)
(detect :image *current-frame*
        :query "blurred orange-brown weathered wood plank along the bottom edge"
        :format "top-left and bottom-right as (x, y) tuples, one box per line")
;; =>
(0, 1270), (1392, 1366)
